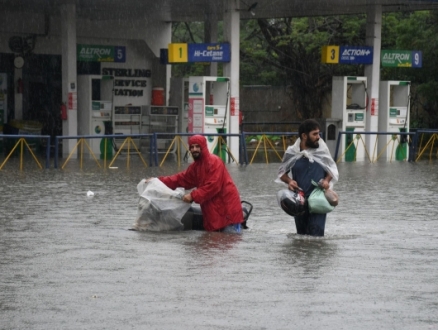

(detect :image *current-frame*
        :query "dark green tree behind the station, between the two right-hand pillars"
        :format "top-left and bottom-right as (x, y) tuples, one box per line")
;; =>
(241, 16), (365, 119)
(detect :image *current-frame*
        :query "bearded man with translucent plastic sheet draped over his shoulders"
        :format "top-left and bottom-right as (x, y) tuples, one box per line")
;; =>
(275, 119), (339, 236)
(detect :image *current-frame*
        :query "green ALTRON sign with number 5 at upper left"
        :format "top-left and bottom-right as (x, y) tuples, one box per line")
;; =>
(76, 44), (126, 63)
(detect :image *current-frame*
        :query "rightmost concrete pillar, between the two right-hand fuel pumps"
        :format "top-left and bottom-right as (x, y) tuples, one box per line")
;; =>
(365, 5), (382, 155)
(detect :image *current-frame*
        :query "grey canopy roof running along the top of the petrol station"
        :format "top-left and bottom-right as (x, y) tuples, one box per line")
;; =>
(0, 0), (438, 22)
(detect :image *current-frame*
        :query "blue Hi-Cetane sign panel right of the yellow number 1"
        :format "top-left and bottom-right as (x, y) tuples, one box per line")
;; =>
(188, 43), (231, 62)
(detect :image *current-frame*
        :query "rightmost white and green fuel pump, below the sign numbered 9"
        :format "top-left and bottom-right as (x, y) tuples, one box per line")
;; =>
(378, 80), (411, 161)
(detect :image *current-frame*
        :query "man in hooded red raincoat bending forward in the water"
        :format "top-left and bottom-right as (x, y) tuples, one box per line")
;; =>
(158, 135), (243, 234)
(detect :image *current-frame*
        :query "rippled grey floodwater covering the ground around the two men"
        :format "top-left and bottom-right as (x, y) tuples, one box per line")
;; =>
(0, 162), (438, 330)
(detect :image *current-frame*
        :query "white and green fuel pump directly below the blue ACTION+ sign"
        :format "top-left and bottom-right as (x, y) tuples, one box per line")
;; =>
(331, 77), (368, 162)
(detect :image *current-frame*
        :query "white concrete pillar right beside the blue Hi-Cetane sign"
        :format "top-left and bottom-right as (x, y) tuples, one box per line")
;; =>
(223, 0), (240, 158)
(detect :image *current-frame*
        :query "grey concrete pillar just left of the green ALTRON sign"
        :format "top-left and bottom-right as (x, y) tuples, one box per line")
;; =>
(60, 3), (77, 158)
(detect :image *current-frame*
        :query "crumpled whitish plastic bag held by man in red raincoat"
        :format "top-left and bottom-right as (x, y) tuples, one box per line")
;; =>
(134, 178), (190, 231)
